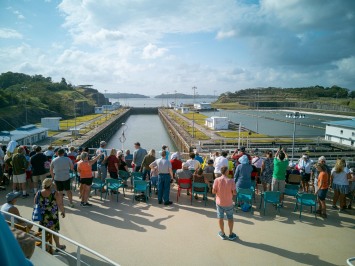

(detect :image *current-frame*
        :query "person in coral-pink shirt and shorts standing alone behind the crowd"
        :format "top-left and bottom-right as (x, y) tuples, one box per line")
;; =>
(212, 166), (237, 240)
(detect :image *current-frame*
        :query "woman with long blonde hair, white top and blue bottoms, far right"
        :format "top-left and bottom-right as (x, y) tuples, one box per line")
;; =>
(330, 159), (351, 212)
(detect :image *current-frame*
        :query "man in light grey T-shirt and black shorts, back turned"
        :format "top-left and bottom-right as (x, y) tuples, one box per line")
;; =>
(50, 149), (74, 208)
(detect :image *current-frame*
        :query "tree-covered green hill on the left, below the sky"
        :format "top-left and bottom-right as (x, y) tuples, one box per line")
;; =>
(0, 72), (108, 130)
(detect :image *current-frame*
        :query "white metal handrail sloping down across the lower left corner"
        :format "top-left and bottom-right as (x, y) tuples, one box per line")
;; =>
(0, 210), (119, 266)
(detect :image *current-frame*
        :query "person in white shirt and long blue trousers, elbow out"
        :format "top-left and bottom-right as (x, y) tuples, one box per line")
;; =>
(149, 151), (173, 205)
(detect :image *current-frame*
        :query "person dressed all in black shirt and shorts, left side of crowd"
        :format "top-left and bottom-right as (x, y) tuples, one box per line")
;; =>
(30, 146), (48, 194)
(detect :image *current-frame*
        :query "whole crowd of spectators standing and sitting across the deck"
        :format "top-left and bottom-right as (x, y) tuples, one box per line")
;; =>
(0, 141), (355, 243)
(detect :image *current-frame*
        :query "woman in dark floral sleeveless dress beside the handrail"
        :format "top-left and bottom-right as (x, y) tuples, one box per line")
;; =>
(34, 178), (66, 250)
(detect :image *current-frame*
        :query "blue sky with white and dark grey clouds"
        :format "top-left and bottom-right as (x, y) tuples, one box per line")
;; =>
(0, 0), (355, 95)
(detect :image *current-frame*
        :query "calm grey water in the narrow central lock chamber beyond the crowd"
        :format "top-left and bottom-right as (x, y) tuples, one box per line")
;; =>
(107, 115), (176, 152)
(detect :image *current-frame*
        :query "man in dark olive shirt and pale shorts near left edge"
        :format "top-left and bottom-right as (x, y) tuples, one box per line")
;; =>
(12, 146), (29, 198)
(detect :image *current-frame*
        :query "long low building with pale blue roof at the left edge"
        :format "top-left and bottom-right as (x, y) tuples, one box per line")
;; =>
(0, 125), (48, 145)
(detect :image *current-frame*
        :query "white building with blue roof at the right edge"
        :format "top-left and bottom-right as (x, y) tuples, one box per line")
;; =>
(324, 119), (355, 147)
